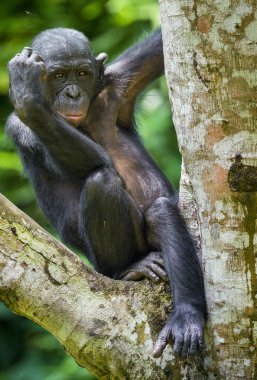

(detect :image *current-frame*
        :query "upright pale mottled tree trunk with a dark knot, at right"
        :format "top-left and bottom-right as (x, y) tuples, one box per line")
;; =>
(160, 0), (257, 380)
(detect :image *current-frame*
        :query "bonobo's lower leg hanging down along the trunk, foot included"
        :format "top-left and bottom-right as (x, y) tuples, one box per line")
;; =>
(145, 197), (206, 357)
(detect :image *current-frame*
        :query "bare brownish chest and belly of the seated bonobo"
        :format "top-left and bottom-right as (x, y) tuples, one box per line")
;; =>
(81, 127), (172, 211)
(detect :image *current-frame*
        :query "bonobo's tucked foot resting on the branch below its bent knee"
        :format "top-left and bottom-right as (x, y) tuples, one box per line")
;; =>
(118, 252), (168, 282)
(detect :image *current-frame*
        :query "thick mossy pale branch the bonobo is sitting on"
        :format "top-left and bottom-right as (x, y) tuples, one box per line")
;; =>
(0, 195), (177, 379)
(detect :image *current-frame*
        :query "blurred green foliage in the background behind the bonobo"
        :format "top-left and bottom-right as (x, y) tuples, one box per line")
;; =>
(0, 0), (180, 380)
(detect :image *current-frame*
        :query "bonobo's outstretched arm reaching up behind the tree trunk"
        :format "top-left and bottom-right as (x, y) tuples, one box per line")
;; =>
(105, 29), (164, 128)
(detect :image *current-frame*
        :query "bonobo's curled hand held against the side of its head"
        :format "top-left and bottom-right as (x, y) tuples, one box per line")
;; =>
(8, 47), (45, 120)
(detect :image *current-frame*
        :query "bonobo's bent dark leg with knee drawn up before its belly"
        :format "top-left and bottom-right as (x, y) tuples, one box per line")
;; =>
(79, 168), (145, 277)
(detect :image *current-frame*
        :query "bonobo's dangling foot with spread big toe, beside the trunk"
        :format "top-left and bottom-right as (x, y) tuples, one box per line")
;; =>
(153, 304), (205, 359)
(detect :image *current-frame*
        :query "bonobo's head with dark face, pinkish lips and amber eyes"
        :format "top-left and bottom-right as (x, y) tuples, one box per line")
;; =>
(31, 28), (107, 127)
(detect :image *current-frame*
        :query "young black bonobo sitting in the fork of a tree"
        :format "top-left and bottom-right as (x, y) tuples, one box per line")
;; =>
(7, 28), (206, 357)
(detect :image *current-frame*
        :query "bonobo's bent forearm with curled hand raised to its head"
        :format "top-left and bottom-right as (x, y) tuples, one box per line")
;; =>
(9, 48), (111, 177)
